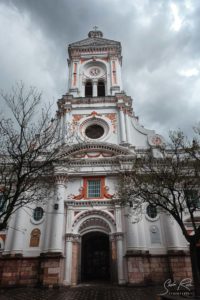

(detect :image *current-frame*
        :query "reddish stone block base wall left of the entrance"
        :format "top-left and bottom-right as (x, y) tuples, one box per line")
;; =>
(0, 257), (63, 287)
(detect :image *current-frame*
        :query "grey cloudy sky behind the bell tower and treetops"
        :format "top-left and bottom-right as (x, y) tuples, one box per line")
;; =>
(0, 0), (200, 136)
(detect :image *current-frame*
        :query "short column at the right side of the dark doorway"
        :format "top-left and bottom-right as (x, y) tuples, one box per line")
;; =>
(115, 232), (126, 284)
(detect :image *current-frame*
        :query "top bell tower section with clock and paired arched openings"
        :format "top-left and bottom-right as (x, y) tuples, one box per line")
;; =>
(68, 27), (122, 97)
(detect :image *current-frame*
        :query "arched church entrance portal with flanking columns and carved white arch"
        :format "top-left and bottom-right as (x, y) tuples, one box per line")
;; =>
(64, 209), (125, 285)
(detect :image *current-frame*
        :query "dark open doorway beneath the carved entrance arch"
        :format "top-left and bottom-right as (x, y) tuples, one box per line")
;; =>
(81, 232), (111, 282)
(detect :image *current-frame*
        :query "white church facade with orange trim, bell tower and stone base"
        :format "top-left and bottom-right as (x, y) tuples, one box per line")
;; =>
(0, 30), (191, 286)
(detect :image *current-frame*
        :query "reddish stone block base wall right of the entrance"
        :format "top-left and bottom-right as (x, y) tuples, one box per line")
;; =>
(126, 253), (192, 285)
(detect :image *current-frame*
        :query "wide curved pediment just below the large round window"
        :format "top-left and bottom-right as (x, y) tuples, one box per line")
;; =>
(58, 143), (133, 159)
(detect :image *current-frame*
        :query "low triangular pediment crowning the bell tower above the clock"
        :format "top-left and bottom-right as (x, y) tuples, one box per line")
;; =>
(69, 38), (120, 48)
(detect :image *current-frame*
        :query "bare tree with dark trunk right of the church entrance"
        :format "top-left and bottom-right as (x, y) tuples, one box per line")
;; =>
(119, 130), (200, 296)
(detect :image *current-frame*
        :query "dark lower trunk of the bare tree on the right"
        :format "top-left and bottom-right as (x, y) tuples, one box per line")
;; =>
(190, 242), (200, 297)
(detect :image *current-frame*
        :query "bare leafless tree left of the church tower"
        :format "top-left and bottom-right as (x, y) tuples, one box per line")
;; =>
(0, 83), (59, 230)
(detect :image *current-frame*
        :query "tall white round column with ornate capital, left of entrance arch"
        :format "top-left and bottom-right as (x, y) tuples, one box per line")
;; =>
(49, 175), (67, 253)
